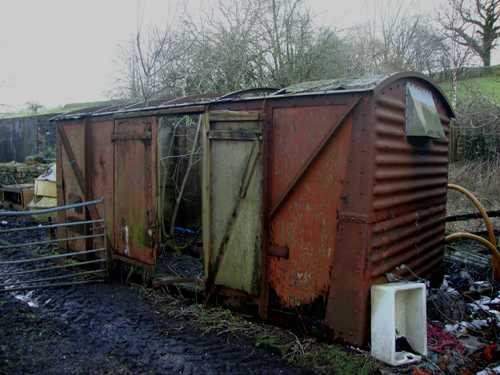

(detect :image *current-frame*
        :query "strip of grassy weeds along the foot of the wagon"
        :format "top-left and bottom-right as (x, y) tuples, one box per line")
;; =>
(140, 286), (378, 375)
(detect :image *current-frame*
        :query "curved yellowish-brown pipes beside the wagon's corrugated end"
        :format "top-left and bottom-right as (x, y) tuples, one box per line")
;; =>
(445, 184), (500, 281)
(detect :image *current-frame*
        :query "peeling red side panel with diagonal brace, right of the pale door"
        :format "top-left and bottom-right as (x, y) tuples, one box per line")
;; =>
(267, 105), (352, 307)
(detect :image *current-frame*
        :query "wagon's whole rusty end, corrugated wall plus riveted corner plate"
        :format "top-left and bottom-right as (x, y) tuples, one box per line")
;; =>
(325, 79), (449, 345)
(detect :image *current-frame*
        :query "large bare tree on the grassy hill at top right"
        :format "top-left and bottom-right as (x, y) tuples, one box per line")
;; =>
(441, 0), (500, 66)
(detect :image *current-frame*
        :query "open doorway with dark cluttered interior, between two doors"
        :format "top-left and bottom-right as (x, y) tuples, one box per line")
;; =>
(155, 114), (203, 286)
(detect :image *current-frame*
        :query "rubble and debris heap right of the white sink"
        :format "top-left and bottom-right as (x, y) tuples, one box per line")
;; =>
(406, 241), (500, 375)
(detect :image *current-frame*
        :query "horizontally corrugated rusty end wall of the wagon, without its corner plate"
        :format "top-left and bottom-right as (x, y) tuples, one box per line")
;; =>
(369, 81), (449, 283)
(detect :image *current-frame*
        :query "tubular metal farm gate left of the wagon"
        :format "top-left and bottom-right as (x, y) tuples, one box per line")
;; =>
(0, 199), (109, 292)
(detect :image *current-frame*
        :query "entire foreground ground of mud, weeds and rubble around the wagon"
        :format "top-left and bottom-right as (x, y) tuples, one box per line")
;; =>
(0, 218), (500, 375)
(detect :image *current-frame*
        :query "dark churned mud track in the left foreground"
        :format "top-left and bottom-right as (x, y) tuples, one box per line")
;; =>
(0, 284), (301, 374)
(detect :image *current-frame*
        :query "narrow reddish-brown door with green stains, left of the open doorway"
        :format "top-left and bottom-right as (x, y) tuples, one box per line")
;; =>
(110, 118), (157, 265)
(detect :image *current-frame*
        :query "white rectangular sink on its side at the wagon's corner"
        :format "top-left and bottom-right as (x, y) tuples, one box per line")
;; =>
(371, 282), (427, 366)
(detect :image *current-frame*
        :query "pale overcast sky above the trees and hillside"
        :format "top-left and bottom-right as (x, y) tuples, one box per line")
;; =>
(0, 0), (500, 112)
